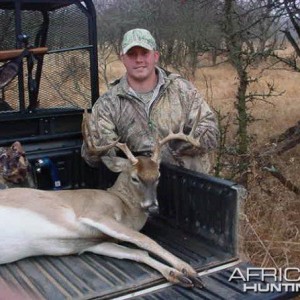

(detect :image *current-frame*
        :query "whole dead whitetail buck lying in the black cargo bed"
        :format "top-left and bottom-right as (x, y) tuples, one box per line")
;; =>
(0, 108), (206, 287)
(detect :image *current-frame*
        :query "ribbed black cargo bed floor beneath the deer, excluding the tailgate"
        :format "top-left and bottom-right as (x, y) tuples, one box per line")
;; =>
(0, 218), (236, 300)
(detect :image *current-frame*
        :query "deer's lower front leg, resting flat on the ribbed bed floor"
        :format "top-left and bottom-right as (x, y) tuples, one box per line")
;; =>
(81, 242), (194, 287)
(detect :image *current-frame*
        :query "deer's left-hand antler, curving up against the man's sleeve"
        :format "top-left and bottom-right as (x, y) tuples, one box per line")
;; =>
(81, 110), (138, 165)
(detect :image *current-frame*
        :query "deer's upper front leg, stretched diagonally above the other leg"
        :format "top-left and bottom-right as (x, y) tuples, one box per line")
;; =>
(79, 217), (203, 287)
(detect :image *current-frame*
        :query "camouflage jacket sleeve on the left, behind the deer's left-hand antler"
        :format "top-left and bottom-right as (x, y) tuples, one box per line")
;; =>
(81, 93), (118, 167)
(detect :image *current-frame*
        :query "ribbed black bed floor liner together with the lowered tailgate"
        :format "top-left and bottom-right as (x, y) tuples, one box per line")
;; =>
(0, 219), (295, 300)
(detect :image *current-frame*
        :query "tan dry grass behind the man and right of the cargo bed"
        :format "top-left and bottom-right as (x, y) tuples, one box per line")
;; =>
(101, 57), (300, 267)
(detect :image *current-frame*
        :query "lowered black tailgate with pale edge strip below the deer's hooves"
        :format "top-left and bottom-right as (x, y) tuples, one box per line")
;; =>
(123, 262), (300, 300)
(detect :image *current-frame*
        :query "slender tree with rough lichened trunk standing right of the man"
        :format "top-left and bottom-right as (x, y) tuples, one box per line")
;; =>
(219, 0), (282, 184)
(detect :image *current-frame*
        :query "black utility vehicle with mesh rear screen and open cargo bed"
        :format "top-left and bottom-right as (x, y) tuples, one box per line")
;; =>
(0, 0), (299, 300)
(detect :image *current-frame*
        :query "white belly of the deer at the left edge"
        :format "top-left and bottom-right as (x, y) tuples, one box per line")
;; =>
(0, 206), (95, 264)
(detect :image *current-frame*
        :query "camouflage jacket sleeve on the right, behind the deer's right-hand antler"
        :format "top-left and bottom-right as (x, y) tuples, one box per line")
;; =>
(170, 80), (219, 156)
